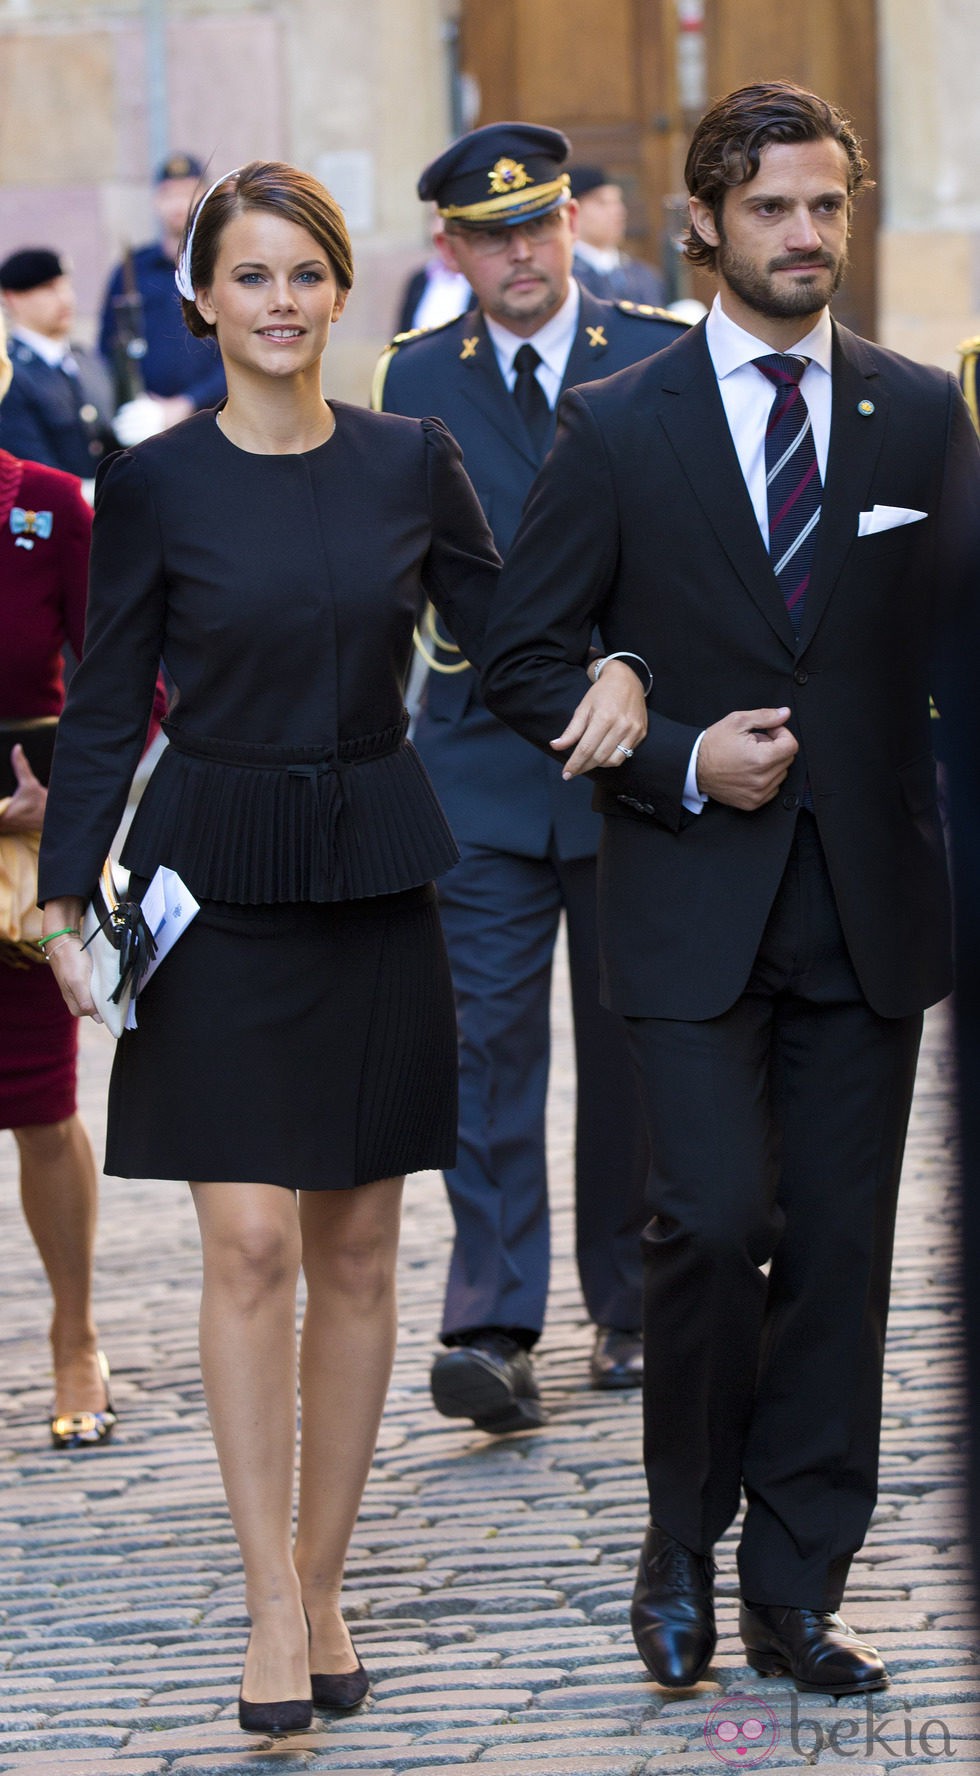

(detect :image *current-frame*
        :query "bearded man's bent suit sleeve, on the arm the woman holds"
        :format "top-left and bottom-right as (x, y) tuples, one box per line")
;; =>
(481, 389), (701, 831)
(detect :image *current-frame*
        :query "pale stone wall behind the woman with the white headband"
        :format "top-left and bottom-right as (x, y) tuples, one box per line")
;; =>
(0, 0), (449, 400)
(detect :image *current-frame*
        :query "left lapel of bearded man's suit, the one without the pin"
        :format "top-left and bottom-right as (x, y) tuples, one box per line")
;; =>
(649, 321), (795, 652)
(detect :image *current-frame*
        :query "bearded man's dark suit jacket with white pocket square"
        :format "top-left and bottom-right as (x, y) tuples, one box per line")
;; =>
(485, 323), (980, 1019)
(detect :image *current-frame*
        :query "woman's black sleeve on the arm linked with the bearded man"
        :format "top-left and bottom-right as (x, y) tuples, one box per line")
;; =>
(419, 419), (501, 666)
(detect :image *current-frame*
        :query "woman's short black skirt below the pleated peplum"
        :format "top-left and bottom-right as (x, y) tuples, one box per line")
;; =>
(105, 879), (456, 1190)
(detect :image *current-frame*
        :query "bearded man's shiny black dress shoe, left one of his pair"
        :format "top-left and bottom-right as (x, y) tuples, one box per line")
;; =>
(630, 1524), (717, 1689)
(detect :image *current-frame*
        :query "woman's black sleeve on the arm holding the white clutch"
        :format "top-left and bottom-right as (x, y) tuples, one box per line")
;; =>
(37, 451), (165, 904)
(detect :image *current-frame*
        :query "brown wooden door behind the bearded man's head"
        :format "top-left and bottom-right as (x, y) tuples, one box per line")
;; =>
(460, 0), (877, 336)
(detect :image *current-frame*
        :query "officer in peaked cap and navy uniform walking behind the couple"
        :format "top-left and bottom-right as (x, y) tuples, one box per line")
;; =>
(375, 123), (684, 1431)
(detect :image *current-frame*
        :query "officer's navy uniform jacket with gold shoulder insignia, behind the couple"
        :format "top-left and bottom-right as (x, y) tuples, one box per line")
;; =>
(375, 291), (685, 858)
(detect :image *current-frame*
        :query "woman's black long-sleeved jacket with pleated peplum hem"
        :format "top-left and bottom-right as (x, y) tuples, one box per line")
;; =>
(39, 401), (499, 904)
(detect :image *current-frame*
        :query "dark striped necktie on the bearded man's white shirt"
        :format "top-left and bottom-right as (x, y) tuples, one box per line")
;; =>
(753, 352), (824, 638)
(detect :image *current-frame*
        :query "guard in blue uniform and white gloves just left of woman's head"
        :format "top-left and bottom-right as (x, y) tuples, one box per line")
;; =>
(99, 153), (225, 444)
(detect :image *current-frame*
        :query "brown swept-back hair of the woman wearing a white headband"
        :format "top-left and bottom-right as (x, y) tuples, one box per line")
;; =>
(181, 160), (353, 339)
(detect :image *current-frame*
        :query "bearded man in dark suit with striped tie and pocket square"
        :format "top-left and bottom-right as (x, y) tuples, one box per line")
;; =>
(485, 82), (980, 1694)
